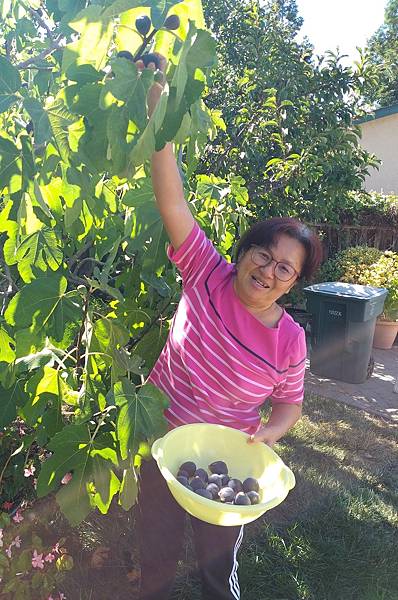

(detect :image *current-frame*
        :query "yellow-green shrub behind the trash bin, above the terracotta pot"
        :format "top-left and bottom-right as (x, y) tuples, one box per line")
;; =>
(319, 246), (398, 321)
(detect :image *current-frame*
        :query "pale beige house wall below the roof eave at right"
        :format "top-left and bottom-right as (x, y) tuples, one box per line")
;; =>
(360, 113), (398, 195)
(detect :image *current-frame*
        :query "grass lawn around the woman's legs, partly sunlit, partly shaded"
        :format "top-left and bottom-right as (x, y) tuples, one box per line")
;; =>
(58, 396), (398, 600)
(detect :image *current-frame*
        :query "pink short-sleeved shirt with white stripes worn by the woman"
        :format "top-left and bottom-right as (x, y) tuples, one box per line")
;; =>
(149, 224), (306, 433)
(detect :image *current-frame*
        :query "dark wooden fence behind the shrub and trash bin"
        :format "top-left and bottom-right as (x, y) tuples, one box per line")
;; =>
(309, 223), (398, 259)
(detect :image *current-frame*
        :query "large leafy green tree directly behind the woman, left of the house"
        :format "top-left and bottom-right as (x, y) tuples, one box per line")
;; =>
(201, 0), (376, 222)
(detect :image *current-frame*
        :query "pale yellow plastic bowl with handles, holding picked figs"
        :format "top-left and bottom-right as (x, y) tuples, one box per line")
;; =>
(152, 423), (295, 525)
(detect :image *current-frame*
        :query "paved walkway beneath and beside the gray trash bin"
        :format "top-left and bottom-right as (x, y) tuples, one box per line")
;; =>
(305, 345), (398, 424)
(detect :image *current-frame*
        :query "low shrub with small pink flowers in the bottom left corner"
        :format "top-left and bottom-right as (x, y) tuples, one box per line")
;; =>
(0, 503), (73, 600)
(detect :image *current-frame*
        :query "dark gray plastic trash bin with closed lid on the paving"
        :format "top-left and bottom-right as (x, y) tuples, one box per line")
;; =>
(304, 282), (387, 383)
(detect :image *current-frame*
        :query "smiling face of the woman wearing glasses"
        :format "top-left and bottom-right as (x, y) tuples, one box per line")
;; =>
(234, 234), (306, 310)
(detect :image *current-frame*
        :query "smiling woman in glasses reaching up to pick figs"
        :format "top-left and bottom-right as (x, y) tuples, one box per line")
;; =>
(137, 55), (321, 600)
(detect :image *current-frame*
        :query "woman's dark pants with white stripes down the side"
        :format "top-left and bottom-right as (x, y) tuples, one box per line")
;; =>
(136, 460), (243, 600)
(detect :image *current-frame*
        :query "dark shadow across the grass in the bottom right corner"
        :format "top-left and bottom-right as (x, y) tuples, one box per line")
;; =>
(240, 492), (398, 600)
